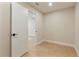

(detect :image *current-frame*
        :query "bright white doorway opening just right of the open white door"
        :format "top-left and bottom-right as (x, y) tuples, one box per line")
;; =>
(28, 10), (37, 51)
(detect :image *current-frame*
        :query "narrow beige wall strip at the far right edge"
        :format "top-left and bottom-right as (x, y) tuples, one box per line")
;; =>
(75, 3), (79, 56)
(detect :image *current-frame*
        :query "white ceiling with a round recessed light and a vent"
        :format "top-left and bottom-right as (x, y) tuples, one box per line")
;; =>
(28, 2), (75, 13)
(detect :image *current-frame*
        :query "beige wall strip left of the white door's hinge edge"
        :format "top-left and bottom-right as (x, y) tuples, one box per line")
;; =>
(0, 2), (10, 57)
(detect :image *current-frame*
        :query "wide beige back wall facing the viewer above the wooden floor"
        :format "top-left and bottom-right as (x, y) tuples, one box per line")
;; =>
(44, 8), (74, 44)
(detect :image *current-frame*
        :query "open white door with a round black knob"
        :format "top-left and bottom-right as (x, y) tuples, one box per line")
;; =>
(12, 3), (28, 57)
